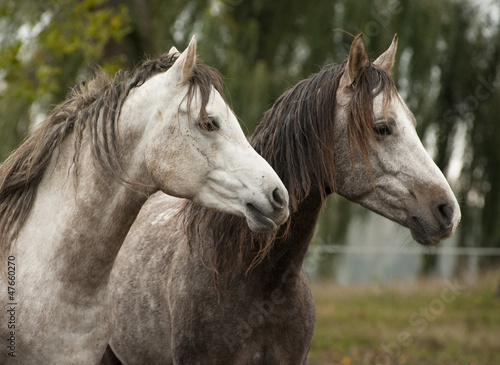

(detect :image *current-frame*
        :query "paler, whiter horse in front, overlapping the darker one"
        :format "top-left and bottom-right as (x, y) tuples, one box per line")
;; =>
(0, 37), (288, 365)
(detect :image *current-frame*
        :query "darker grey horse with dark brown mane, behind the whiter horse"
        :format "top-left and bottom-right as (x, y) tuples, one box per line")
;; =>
(102, 36), (460, 365)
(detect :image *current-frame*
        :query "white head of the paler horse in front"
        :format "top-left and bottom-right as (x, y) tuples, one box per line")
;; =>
(122, 37), (288, 231)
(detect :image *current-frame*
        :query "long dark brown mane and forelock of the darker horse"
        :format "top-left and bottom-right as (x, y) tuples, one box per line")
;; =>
(181, 61), (398, 286)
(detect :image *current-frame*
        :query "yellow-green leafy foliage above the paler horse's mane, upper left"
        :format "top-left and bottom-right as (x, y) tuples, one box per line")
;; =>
(0, 0), (130, 157)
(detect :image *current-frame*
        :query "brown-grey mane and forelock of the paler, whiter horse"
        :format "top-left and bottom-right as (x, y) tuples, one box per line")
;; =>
(0, 53), (224, 267)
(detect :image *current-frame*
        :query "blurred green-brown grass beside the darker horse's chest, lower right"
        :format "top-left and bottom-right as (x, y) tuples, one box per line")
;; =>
(309, 272), (500, 365)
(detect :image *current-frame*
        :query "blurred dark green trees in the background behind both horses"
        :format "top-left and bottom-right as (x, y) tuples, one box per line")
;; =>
(0, 0), (500, 275)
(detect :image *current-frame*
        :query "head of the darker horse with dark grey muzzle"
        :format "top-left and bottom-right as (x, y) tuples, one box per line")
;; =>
(334, 35), (460, 245)
